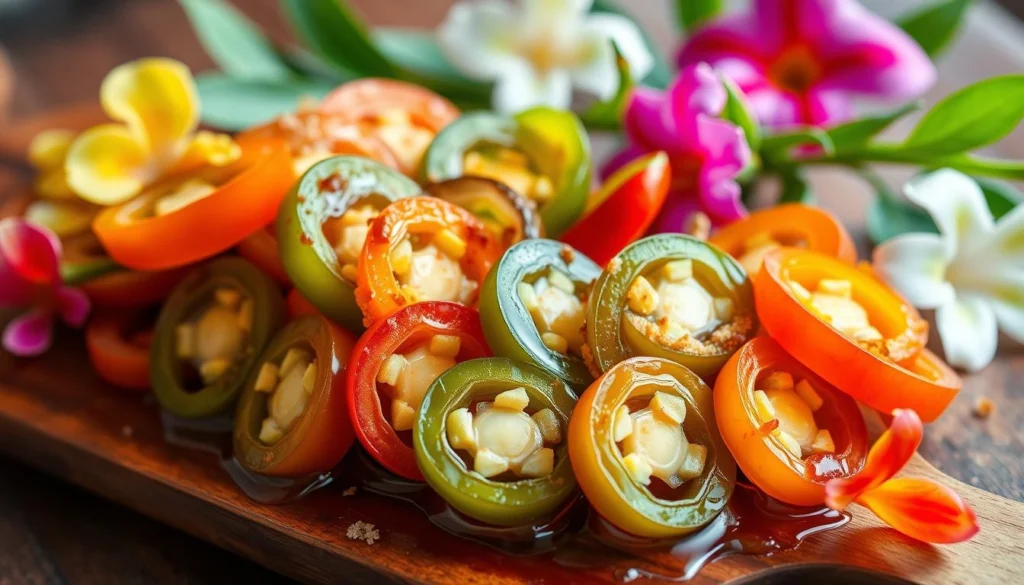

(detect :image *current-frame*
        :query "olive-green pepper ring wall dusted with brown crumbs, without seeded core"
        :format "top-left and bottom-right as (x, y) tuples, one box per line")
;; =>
(587, 234), (758, 379)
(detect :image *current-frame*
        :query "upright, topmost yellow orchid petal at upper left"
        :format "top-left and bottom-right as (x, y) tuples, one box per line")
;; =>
(99, 58), (200, 155)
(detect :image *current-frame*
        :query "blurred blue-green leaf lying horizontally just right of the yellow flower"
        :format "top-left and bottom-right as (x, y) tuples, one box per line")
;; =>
(196, 74), (334, 131)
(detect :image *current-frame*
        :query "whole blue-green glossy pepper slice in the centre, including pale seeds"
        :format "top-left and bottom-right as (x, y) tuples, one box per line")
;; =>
(480, 240), (601, 390)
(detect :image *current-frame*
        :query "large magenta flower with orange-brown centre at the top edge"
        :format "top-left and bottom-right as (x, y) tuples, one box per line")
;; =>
(678, 0), (936, 128)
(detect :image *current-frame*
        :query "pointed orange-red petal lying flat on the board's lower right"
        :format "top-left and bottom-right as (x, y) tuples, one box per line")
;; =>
(857, 477), (978, 544)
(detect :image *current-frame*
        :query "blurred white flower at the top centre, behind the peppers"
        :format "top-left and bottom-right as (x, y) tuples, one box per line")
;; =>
(438, 0), (654, 113)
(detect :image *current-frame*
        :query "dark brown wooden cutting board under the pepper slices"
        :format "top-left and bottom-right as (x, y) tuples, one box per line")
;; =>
(0, 107), (1024, 585)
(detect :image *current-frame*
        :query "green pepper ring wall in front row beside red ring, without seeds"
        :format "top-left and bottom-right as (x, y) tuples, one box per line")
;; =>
(413, 358), (577, 526)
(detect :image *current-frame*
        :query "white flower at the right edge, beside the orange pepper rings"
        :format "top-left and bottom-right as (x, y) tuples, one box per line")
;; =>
(874, 169), (1024, 371)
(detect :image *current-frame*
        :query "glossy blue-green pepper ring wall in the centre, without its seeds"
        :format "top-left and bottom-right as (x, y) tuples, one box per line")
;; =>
(480, 240), (601, 390)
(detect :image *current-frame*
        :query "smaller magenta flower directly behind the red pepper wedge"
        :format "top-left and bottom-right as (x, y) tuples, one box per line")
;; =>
(604, 64), (751, 227)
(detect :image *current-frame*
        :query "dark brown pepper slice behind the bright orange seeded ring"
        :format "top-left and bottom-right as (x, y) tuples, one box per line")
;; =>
(423, 176), (544, 248)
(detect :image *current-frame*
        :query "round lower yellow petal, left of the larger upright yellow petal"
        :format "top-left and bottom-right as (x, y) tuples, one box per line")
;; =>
(65, 124), (156, 205)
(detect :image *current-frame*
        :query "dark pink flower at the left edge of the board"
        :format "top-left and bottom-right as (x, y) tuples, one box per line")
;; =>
(0, 217), (89, 356)
